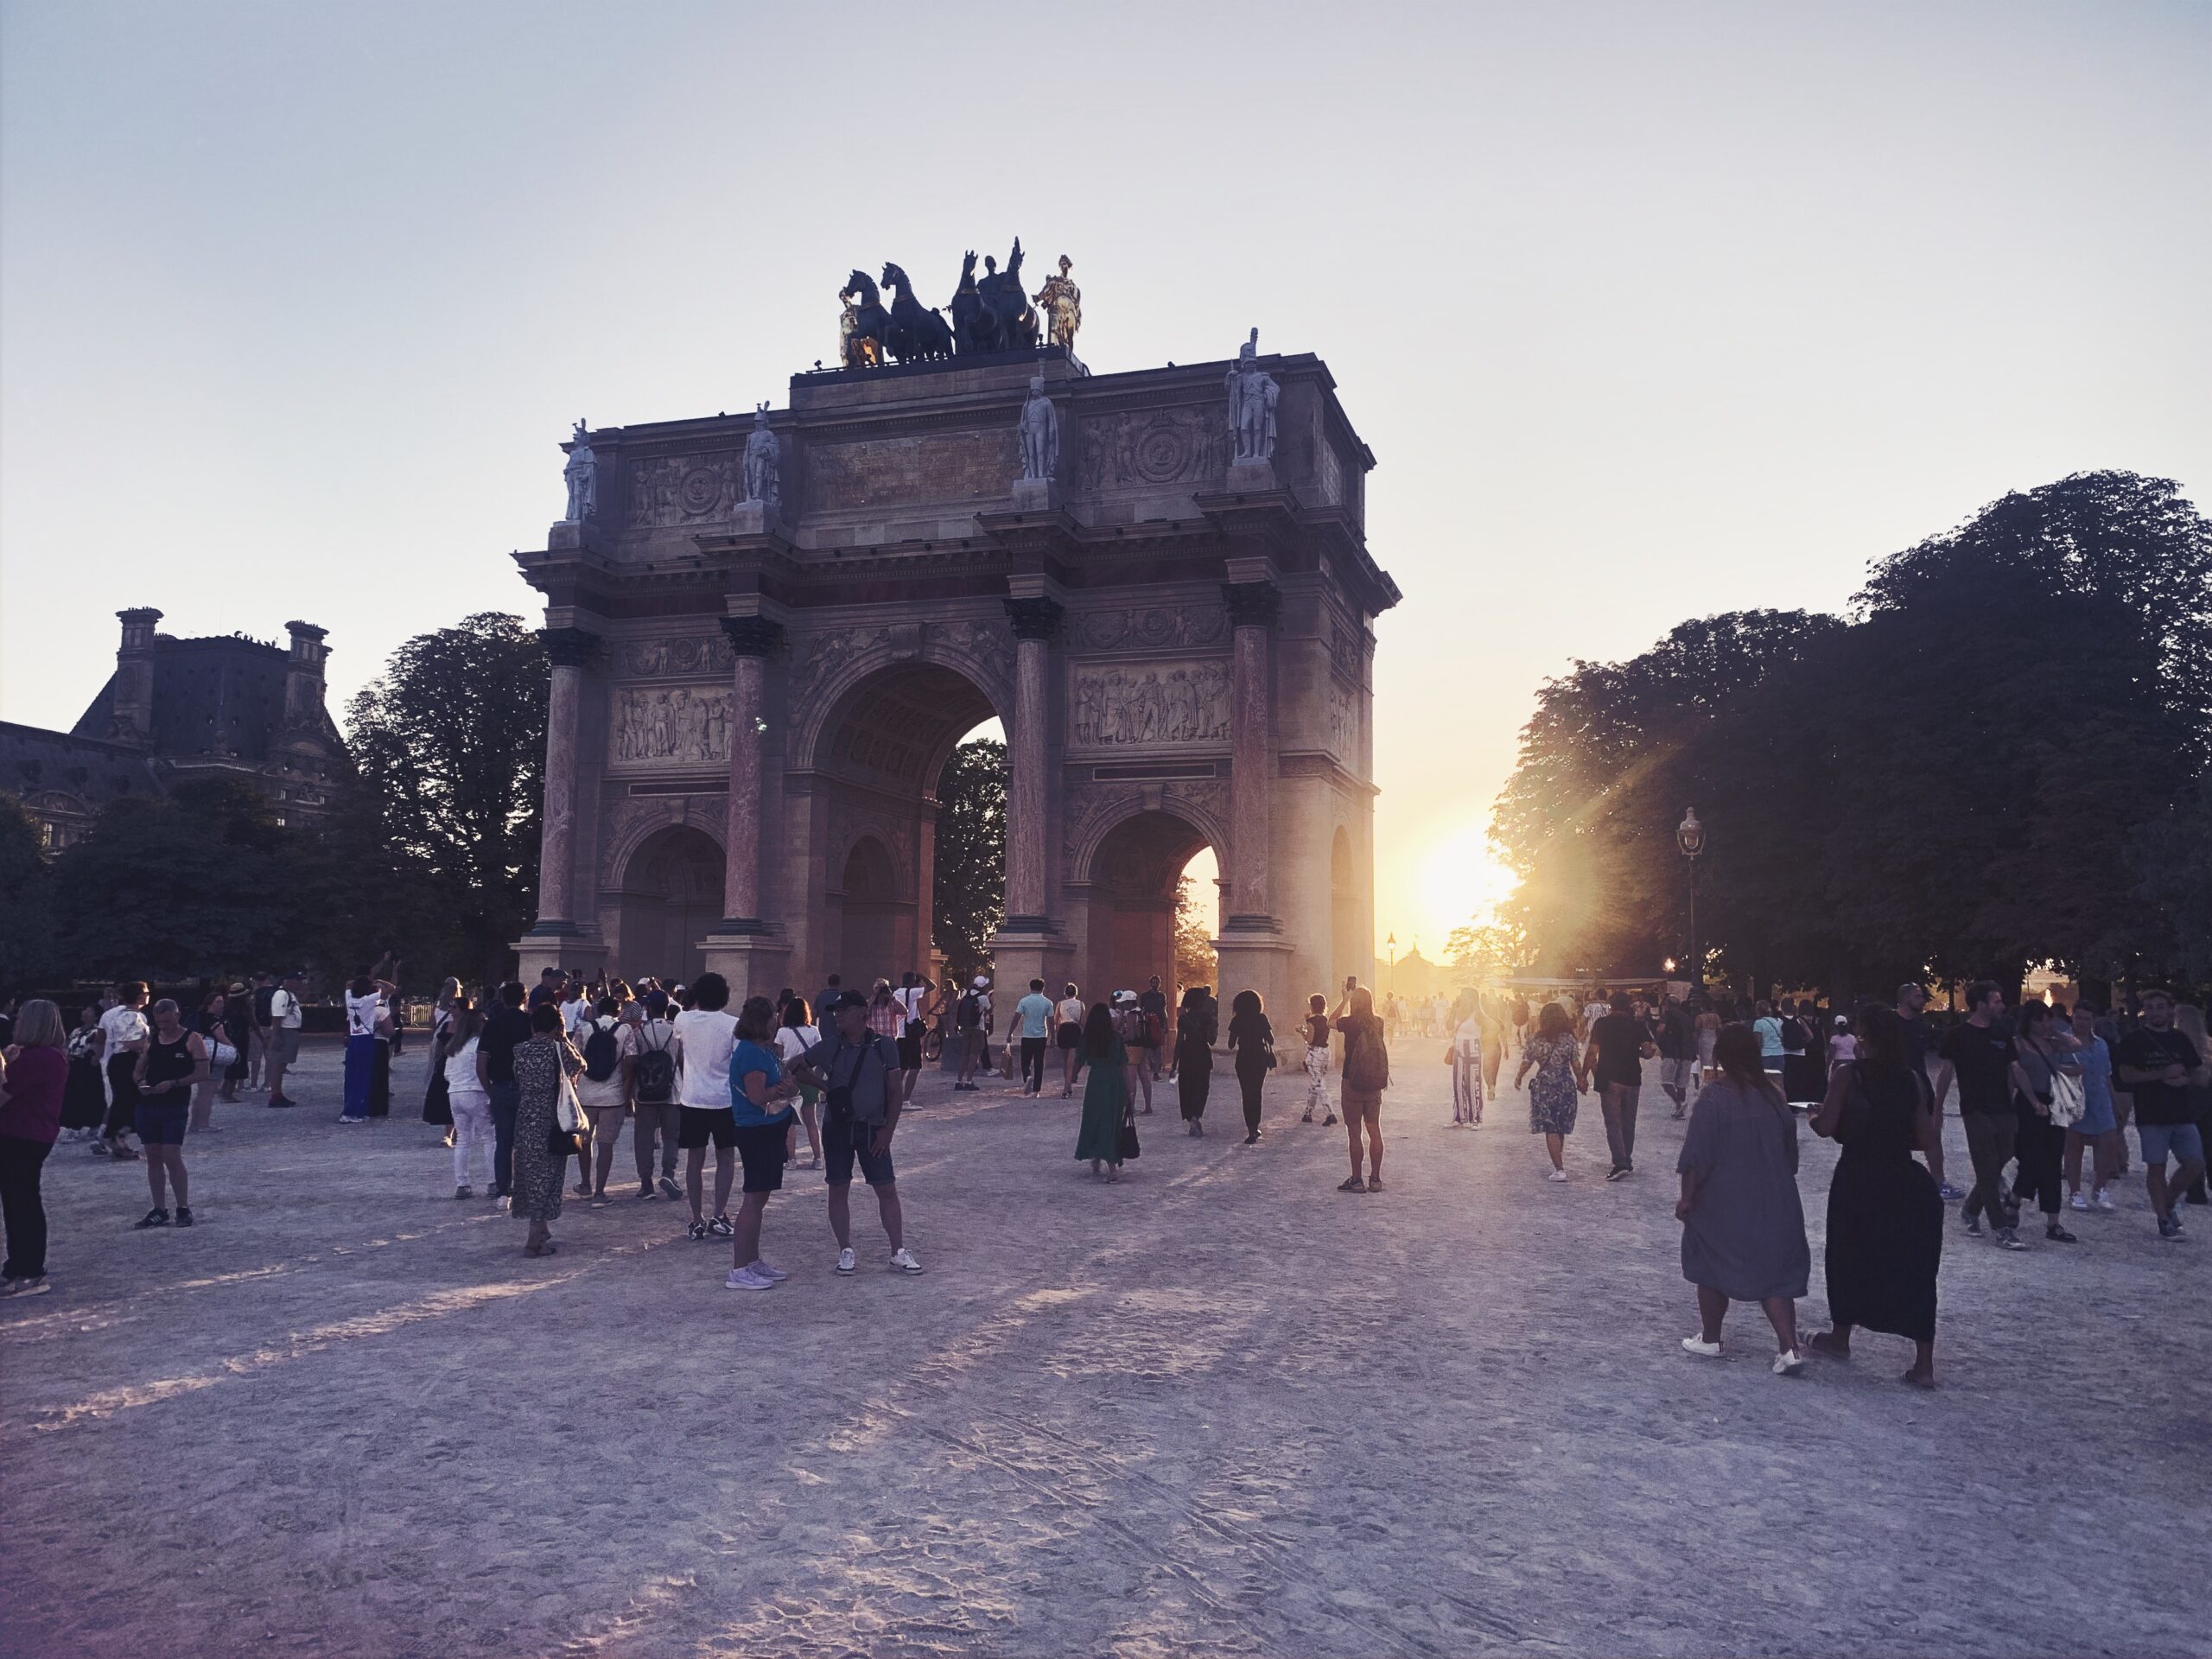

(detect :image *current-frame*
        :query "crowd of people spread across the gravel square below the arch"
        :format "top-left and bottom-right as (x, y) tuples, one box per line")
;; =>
(0, 973), (2212, 1385)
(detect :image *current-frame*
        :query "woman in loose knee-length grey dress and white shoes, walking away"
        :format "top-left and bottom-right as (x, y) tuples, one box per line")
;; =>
(1675, 1024), (1812, 1376)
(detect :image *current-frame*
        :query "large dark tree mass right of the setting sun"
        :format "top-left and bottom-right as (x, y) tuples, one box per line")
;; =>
(1493, 474), (2212, 988)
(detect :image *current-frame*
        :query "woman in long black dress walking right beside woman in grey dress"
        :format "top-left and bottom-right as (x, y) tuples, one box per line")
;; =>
(1812, 1007), (1942, 1389)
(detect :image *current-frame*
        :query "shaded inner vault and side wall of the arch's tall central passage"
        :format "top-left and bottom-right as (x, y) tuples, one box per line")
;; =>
(794, 661), (1000, 987)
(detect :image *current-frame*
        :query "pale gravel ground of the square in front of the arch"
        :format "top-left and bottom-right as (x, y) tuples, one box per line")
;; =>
(0, 1042), (2212, 1659)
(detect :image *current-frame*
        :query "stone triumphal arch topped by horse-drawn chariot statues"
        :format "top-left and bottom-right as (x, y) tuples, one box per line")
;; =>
(515, 259), (1398, 1011)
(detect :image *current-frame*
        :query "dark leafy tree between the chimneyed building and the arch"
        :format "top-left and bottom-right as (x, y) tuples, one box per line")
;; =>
(349, 611), (549, 980)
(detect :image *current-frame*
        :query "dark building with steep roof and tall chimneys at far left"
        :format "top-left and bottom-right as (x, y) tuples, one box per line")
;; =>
(0, 608), (349, 852)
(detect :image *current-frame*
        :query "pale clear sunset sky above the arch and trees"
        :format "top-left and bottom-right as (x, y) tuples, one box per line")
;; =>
(0, 0), (2212, 956)
